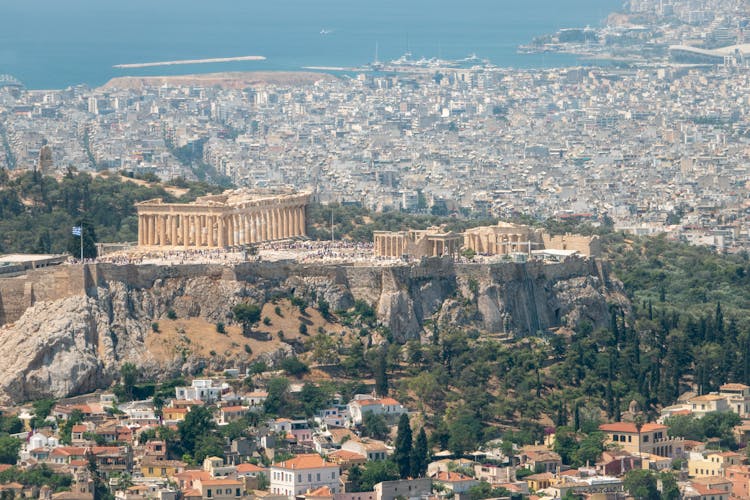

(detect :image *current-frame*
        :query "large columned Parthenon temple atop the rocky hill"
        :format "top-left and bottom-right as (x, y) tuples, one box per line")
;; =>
(136, 189), (310, 248)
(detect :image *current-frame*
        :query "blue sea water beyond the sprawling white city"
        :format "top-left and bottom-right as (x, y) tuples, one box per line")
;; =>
(0, 0), (621, 89)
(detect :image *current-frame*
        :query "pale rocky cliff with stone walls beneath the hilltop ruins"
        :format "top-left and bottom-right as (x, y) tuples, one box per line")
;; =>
(0, 259), (626, 403)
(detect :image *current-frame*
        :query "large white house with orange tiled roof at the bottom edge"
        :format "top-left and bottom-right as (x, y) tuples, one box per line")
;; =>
(269, 454), (341, 497)
